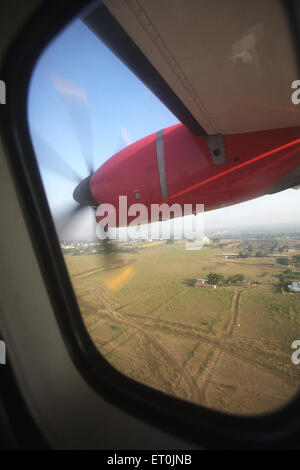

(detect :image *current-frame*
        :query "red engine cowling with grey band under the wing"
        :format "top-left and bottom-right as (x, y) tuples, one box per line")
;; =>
(90, 124), (300, 226)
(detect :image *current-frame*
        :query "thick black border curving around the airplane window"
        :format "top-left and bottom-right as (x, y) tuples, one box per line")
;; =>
(0, 0), (300, 448)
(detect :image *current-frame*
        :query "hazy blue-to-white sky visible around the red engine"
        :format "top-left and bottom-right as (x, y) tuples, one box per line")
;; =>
(28, 20), (300, 236)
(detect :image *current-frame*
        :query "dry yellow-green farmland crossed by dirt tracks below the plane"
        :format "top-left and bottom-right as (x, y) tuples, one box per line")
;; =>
(65, 237), (300, 414)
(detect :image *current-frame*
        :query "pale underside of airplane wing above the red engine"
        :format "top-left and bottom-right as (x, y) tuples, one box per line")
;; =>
(84, 0), (300, 135)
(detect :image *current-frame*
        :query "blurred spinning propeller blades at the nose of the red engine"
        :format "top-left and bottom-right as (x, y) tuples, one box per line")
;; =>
(32, 76), (129, 267)
